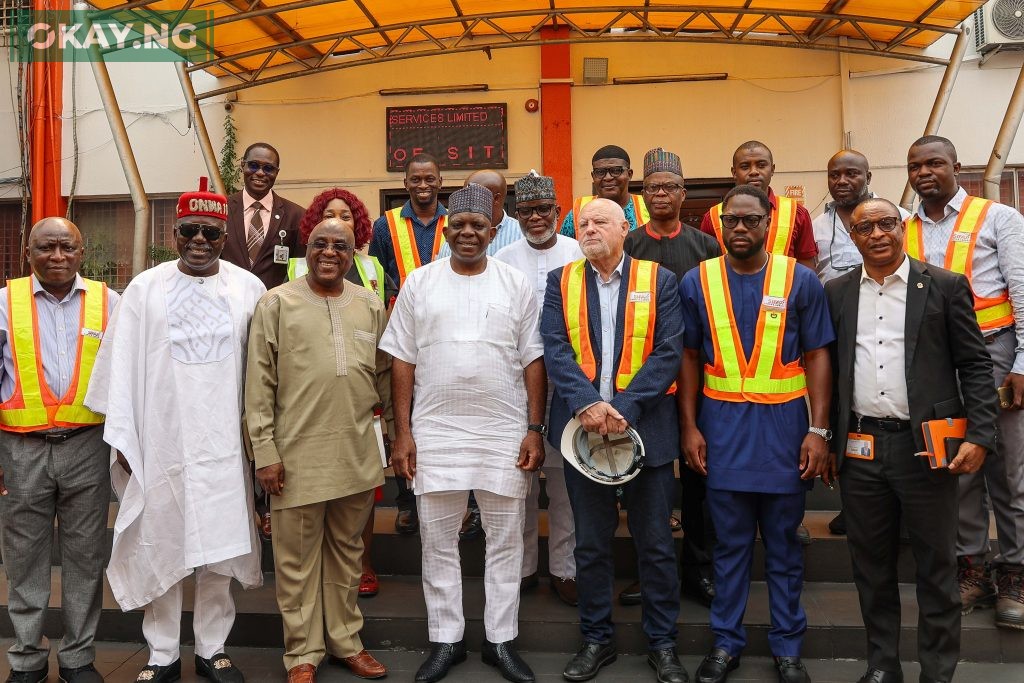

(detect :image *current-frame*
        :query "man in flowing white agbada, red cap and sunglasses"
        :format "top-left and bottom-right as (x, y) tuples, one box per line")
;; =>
(85, 178), (266, 683)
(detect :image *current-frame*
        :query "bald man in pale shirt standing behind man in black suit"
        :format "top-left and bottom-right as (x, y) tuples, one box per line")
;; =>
(813, 150), (910, 285)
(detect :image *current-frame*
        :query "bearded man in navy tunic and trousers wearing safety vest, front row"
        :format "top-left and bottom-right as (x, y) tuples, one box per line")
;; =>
(679, 184), (836, 683)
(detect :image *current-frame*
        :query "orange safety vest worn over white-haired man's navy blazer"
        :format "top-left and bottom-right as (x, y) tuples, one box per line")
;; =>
(562, 258), (676, 393)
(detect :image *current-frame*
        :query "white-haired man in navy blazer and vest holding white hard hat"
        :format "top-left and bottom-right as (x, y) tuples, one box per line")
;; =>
(541, 199), (689, 683)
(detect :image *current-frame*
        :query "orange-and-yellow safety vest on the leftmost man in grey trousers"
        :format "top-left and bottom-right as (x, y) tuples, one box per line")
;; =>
(0, 278), (109, 432)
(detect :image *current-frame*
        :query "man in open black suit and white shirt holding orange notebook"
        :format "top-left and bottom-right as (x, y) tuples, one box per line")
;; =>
(825, 199), (997, 683)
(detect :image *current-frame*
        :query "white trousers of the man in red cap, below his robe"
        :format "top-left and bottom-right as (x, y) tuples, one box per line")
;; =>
(142, 566), (234, 667)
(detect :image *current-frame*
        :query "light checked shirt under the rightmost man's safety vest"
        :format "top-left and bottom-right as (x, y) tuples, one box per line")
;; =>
(918, 187), (1024, 375)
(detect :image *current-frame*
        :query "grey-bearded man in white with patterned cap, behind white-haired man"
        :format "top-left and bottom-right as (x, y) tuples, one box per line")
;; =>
(495, 171), (583, 606)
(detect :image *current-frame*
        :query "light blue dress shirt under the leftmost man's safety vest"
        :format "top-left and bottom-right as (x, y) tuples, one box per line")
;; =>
(0, 275), (121, 401)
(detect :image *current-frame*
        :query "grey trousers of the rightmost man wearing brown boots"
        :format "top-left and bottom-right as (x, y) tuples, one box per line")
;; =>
(956, 332), (1024, 565)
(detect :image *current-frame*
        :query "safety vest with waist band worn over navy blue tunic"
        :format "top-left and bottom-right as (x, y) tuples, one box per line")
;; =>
(700, 254), (807, 403)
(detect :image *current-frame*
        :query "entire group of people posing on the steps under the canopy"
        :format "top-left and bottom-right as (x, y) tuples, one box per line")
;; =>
(0, 131), (1024, 683)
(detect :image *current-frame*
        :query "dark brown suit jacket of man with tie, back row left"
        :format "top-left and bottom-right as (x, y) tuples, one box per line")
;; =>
(220, 191), (306, 290)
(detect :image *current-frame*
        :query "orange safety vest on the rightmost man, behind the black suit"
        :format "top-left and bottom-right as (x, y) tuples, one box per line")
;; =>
(903, 197), (1014, 332)
